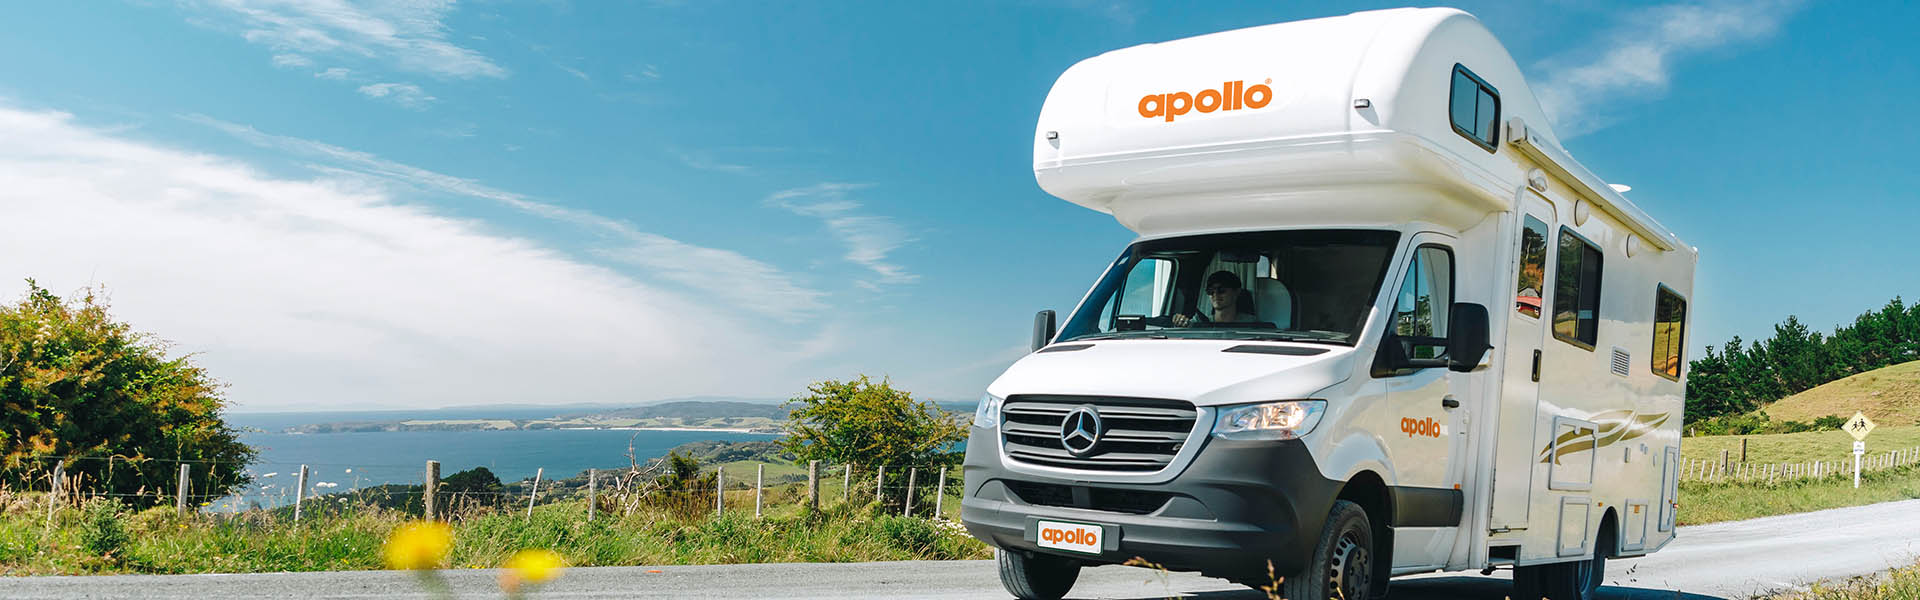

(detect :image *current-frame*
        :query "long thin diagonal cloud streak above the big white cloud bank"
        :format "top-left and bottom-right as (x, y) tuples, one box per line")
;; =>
(186, 115), (826, 323)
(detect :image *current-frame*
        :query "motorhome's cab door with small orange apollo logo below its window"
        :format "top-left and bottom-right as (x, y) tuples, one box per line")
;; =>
(1375, 233), (1469, 569)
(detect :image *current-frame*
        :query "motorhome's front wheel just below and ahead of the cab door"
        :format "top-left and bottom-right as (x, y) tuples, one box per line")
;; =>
(1281, 500), (1384, 600)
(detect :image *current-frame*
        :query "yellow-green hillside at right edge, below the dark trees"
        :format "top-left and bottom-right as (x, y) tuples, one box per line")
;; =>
(1764, 362), (1920, 425)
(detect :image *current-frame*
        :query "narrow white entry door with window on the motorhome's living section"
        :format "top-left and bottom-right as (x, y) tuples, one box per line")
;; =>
(1488, 190), (1553, 529)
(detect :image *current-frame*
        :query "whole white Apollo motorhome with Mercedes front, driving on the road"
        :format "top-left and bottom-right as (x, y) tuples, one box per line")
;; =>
(962, 10), (1697, 600)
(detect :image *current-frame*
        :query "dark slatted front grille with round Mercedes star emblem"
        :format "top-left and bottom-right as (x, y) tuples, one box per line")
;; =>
(1000, 396), (1198, 471)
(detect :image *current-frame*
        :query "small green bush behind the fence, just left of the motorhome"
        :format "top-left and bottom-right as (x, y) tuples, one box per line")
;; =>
(783, 375), (966, 465)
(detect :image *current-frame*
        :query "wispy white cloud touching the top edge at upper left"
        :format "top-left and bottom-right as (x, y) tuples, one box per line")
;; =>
(192, 0), (507, 79)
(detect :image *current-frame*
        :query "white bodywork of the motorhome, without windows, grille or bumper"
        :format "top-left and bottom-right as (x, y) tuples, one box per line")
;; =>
(989, 10), (1697, 573)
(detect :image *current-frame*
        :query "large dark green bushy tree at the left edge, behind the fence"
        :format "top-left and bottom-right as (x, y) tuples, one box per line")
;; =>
(0, 279), (253, 506)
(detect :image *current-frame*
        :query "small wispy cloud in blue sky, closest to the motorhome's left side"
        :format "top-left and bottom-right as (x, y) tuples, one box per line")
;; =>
(766, 183), (920, 290)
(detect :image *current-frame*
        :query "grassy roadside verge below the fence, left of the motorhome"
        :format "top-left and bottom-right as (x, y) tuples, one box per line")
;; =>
(0, 484), (991, 575)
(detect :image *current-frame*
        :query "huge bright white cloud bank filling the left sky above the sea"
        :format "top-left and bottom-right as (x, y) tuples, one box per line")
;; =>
(0, 106), (821, 410)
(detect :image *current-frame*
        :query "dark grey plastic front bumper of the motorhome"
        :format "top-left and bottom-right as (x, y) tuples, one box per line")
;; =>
(960, 427), (1340, 579)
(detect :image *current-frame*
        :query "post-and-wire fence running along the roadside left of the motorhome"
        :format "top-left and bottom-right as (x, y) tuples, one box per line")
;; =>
(0, 456), (960, 523)
